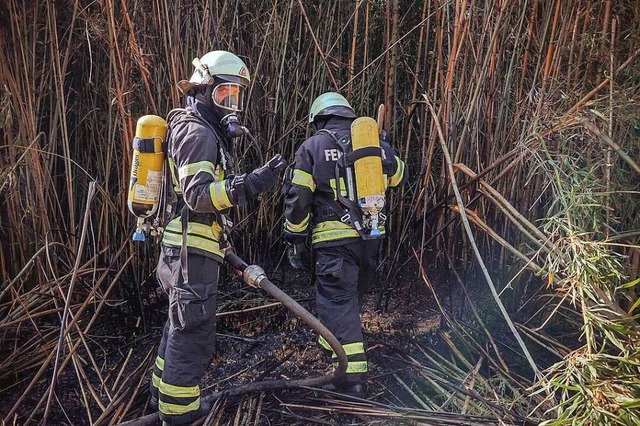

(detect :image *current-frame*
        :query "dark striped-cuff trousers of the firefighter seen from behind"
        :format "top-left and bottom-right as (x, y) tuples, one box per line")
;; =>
(315, 240), (380, 384)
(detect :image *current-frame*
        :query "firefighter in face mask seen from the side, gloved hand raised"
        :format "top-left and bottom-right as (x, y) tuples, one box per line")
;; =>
(151, 51), (285, 425)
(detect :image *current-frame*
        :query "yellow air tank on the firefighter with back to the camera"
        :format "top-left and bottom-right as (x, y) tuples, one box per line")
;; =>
(351, 117), (385, 237)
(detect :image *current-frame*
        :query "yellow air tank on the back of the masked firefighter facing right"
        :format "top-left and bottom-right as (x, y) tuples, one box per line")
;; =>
(127, 115), (167, 241)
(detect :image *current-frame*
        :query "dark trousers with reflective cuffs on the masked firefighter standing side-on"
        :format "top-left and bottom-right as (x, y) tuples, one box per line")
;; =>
(151, 245), (220, 425)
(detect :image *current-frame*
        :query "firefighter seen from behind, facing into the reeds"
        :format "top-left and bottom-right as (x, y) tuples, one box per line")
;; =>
(283, 92), (405, 397)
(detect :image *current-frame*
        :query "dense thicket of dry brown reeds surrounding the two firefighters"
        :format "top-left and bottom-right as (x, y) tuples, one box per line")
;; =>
(0, 0), (640, 425)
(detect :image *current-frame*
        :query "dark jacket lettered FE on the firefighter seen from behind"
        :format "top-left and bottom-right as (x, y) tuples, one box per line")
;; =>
(284, 116), (405, 247)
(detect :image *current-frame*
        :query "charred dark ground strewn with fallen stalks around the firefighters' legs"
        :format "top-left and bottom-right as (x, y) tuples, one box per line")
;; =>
(0, 260), (498, 425)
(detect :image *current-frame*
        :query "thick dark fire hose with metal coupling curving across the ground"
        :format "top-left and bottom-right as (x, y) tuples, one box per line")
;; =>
(121, 250), (347, 426)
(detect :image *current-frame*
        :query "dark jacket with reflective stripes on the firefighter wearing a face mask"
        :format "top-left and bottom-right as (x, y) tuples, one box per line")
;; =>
(162, 106), (233, 261)
